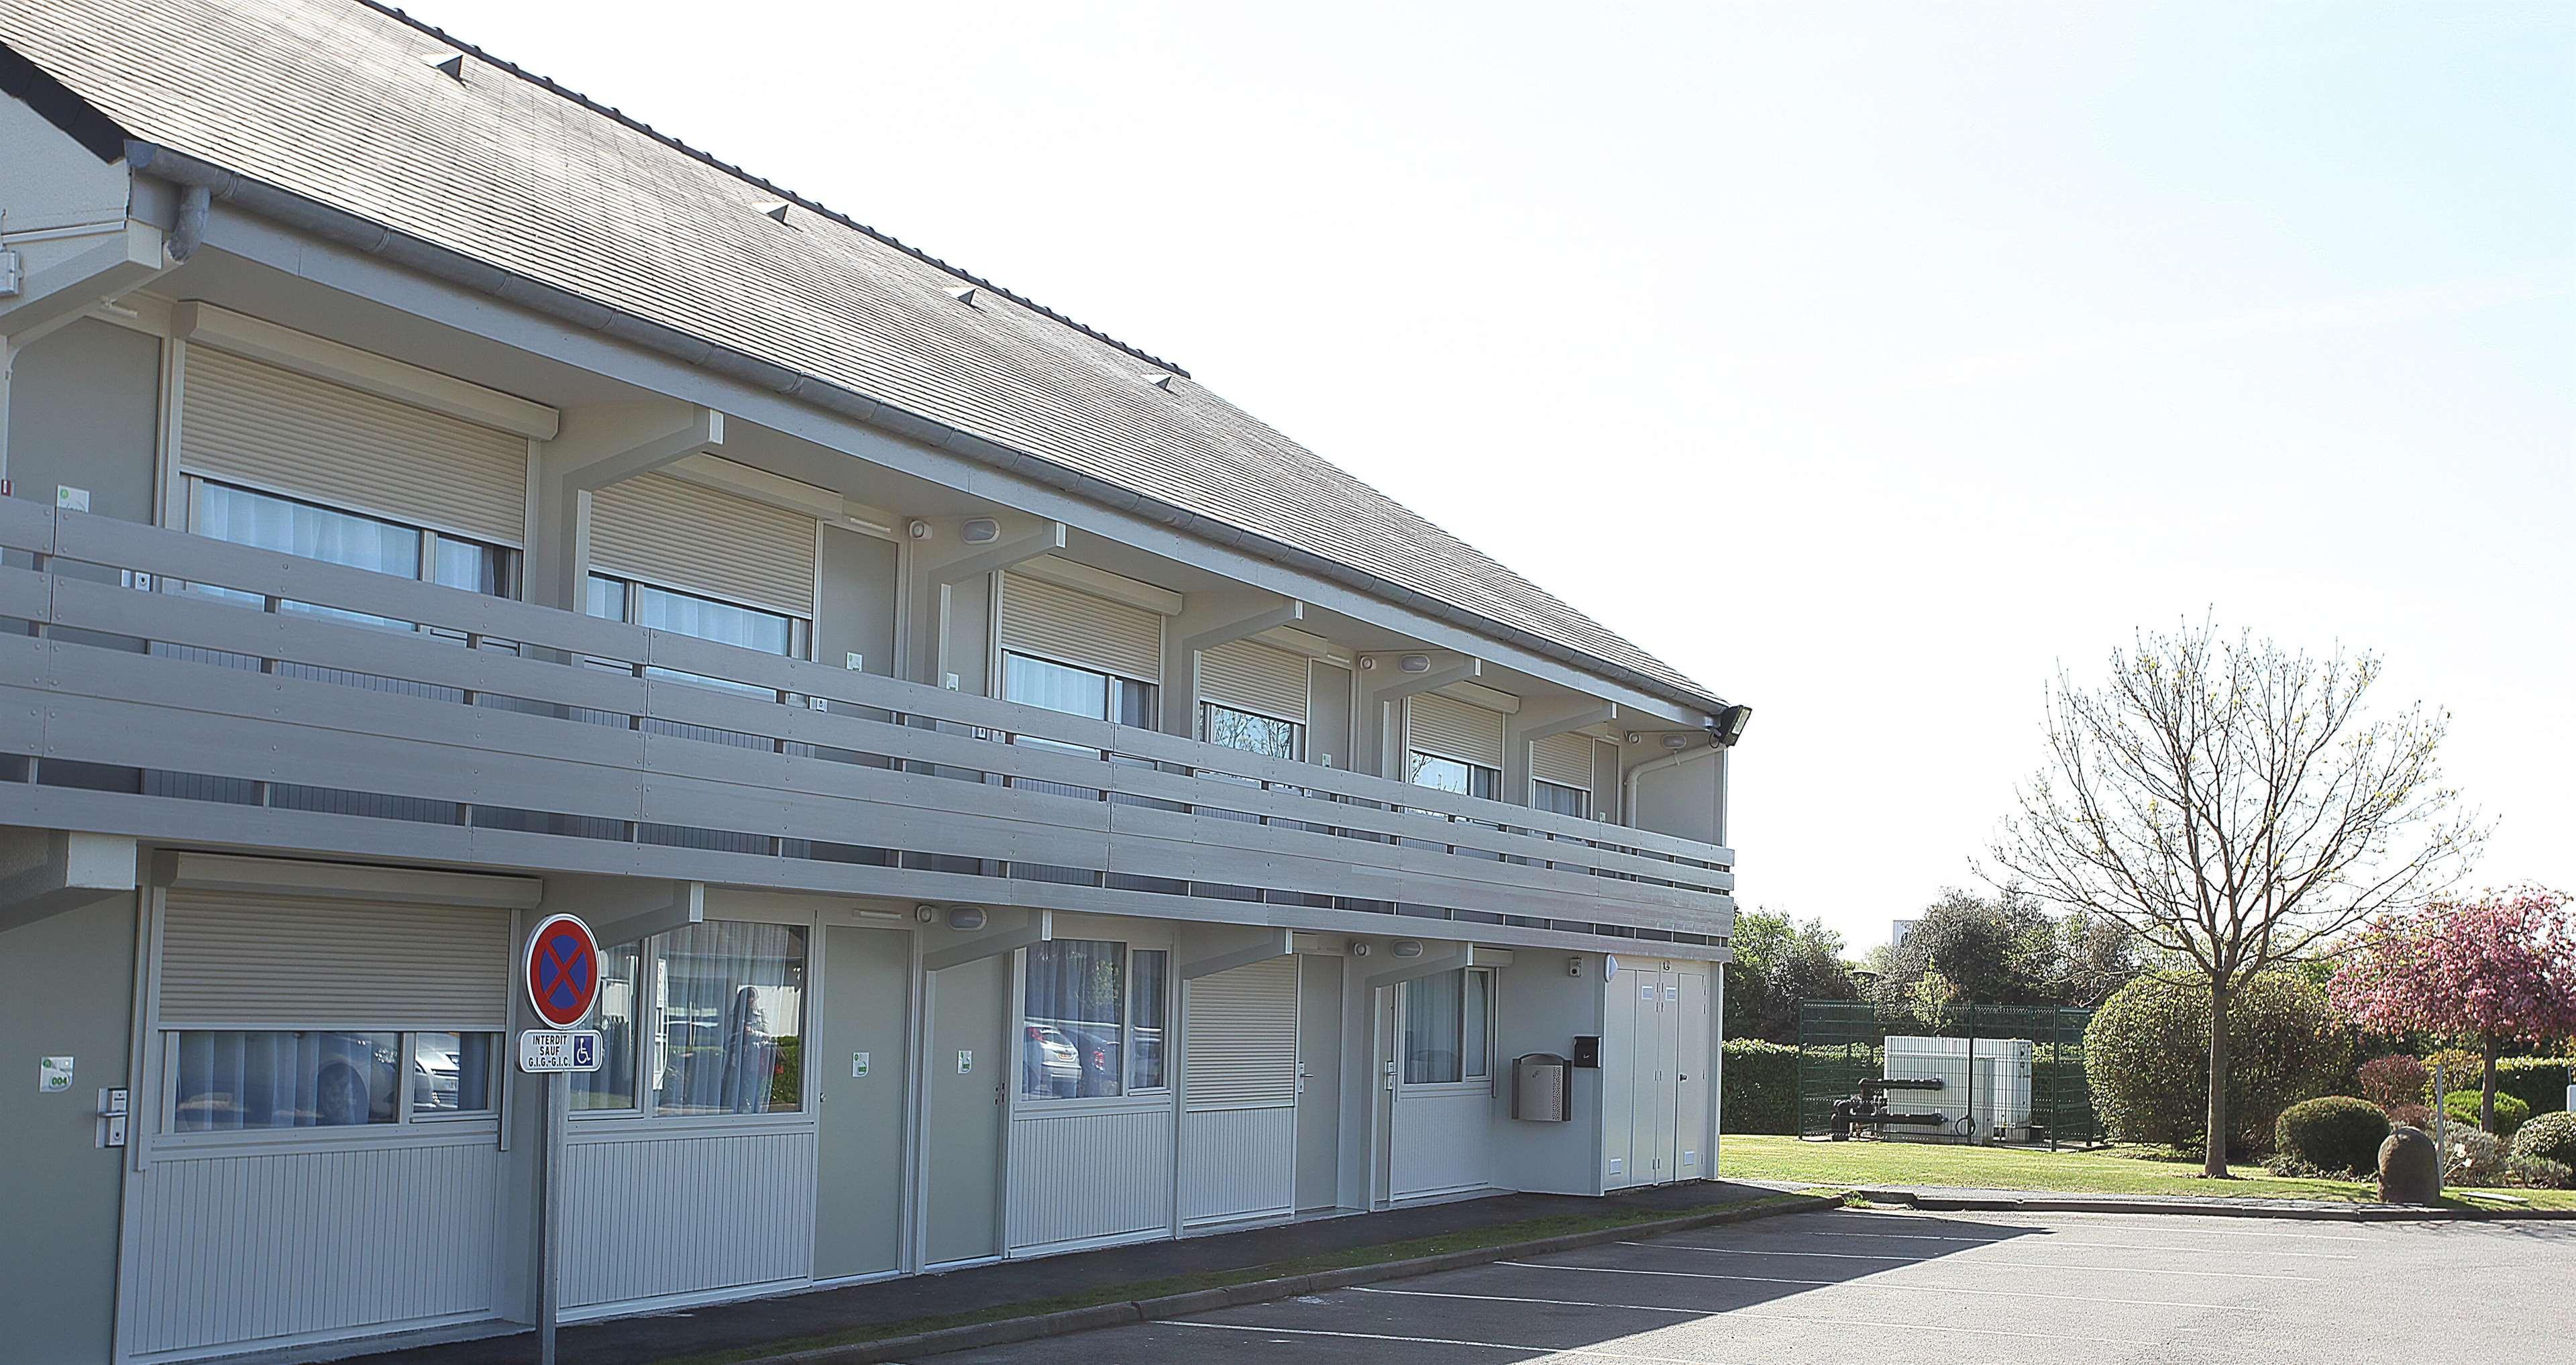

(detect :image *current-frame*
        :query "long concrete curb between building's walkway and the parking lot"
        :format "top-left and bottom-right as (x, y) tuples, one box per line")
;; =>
(742, 1193), (1842, 1365)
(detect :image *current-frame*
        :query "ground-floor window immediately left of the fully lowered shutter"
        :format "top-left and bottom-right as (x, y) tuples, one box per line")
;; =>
(1020, 938), (1172, 1100)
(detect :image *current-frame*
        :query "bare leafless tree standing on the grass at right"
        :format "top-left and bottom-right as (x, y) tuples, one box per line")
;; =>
(1988, 620), (2486, 1177)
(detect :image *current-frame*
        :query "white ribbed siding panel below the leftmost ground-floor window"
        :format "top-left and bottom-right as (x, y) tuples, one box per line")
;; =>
(123, 1136), (502, 1357)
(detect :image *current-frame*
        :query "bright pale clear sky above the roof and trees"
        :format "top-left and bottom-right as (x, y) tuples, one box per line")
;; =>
(412, 0), (2576, 950)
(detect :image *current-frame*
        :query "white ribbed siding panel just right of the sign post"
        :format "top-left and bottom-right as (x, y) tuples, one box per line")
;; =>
(564, 1128), (814, 1309)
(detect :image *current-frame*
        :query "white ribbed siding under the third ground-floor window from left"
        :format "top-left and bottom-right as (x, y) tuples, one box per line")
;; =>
(1002, 1105), (1172, 1254)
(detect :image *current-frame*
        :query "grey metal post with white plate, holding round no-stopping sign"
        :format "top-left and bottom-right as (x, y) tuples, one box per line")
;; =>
(518, 914), (600, 1365)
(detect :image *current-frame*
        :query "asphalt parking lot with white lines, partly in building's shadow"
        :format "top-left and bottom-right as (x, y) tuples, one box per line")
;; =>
(932, 1211), (2576, 1365)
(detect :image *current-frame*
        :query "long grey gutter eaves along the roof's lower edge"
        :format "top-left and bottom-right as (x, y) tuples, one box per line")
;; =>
(123, 139), (1726, 714)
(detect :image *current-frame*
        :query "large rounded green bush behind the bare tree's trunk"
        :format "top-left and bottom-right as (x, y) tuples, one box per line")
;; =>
(2084, 971), (2352, 1156)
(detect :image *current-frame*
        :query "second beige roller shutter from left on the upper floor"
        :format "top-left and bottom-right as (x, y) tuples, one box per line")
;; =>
(590, 474), (814, 618)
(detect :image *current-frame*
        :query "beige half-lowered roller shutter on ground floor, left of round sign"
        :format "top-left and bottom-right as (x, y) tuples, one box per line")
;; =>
(160, 891), (510, 1030)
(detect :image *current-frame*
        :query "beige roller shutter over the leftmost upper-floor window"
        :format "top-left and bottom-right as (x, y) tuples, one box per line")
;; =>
(178, 345), (528, 546)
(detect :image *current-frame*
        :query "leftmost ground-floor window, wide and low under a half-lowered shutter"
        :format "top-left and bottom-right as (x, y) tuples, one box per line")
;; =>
(170, 1028), (500, 1133)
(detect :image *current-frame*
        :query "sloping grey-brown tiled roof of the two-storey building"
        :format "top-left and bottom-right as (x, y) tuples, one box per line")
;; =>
(0, 0), (1715, 706)
